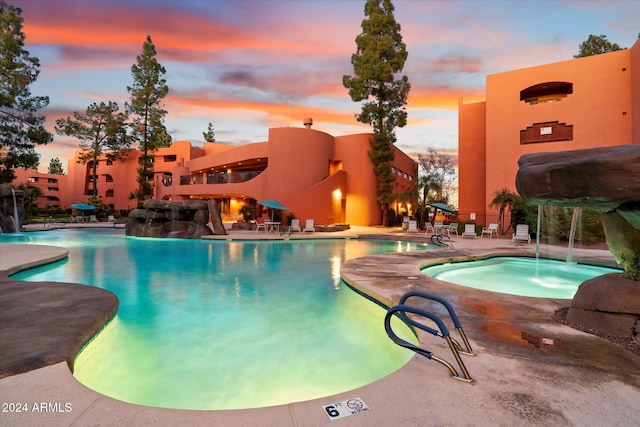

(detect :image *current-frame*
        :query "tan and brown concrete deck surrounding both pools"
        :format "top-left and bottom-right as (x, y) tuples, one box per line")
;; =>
(0, 224), (640, 427)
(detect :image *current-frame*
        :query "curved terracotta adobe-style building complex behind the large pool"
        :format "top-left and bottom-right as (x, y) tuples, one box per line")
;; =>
(14, 119), (418, 226)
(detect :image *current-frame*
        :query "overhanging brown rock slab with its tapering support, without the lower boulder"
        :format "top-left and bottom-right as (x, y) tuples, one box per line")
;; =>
(516, 144), (640, 278)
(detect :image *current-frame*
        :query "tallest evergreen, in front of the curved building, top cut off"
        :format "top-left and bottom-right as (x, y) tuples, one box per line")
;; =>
(342, 0), (411, 225)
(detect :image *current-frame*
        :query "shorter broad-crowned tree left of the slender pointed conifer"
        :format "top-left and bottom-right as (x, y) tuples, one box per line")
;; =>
(56, 101), (131, 196)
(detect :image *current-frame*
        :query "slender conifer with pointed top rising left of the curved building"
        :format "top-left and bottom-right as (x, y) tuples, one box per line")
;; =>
(127, 36), (171, 201)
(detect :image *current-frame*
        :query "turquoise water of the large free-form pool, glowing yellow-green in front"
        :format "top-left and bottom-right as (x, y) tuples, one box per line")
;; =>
(5, 229), (426, 409)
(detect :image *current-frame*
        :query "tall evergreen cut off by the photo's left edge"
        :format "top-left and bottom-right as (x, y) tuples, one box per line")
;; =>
(0, 1), (53, 182)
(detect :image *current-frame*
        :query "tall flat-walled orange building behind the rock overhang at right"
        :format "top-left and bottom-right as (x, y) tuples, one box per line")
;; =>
(458, 41), (640, 229)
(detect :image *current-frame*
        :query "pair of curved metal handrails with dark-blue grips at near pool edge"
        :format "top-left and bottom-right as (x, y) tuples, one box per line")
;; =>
(384, 291), (475, 383)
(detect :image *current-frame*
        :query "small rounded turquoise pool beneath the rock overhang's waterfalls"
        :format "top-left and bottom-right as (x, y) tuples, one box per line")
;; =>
(422, 257), (621, 299)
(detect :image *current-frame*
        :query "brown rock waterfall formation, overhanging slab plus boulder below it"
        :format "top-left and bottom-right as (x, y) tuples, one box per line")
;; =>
(516, 144), (640, 336)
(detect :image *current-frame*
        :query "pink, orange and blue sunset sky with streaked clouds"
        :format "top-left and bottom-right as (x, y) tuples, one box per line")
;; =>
(11, 0), (640, 172)
